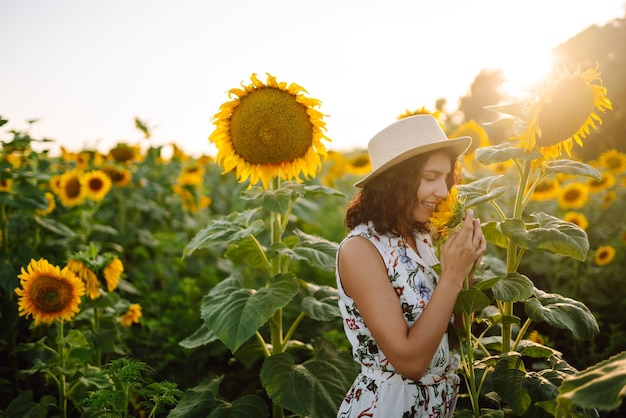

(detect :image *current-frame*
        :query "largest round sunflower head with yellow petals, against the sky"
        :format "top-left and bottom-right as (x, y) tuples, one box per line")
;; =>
(209, 74), (329, 188)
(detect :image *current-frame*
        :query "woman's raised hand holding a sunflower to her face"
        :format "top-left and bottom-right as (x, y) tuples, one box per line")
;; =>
(440, 209), (487, 288)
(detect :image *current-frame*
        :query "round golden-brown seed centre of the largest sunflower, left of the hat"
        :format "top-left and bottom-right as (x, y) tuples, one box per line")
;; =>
(230, 87), (313, 164)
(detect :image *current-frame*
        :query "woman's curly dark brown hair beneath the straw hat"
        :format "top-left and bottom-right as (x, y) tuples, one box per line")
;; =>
(344, 150), (458, 237)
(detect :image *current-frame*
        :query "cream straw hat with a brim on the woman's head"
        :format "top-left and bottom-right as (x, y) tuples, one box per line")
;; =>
(354, 114), (472, 187)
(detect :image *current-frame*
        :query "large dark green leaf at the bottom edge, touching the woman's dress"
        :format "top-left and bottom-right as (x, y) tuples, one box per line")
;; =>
(261, 340), (356, 418)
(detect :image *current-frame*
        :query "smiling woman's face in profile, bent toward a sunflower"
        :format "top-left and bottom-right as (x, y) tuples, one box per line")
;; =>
(413, 152), (452, 223)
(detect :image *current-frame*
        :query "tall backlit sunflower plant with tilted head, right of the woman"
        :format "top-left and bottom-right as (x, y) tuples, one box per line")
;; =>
(446, 64), (622, 417)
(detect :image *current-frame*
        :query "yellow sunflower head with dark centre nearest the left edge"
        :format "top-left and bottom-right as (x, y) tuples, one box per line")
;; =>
(15, 258), (85, 325)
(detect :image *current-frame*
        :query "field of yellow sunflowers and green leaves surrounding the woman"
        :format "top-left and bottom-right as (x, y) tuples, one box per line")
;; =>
(0, 68), (626, 418)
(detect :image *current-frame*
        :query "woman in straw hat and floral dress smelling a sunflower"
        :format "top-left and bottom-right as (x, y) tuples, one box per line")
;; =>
(336, 115), (487, 418)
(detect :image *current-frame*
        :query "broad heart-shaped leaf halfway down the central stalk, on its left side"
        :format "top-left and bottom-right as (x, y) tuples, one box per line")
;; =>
(200, 273), (298, 352)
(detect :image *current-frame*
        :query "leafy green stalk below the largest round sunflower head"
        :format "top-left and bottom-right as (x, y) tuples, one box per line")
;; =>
(179, 179), (356, 417)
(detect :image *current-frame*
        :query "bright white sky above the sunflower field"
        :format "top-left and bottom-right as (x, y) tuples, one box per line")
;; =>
(0, 0), (626, 156)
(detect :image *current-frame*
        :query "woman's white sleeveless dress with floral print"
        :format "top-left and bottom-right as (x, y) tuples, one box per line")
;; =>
(336, 223), (460, 418)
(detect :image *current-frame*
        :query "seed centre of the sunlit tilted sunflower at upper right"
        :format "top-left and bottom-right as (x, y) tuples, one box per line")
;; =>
(537, 77), (595, 147)
